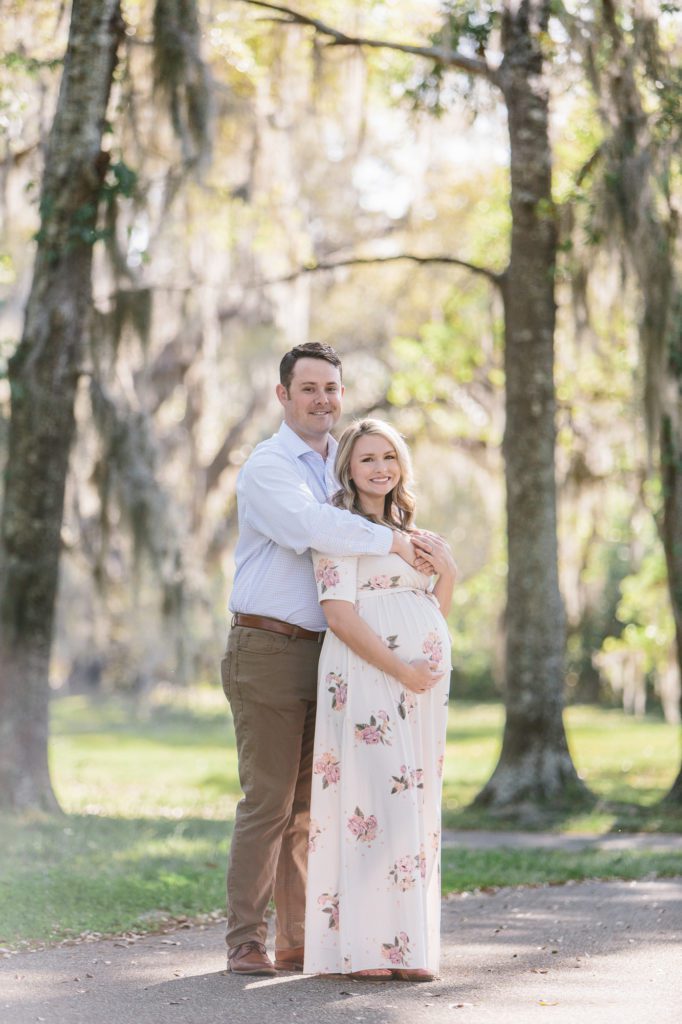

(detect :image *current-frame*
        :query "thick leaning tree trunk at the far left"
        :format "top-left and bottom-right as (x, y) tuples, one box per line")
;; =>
(0, 0), (123, 810)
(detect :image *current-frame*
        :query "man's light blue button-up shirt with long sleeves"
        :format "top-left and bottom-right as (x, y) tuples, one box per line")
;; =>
(229, 423), (393, 630)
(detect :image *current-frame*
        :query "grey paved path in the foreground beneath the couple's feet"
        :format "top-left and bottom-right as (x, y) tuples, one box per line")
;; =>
(0, 876), (682, 1024)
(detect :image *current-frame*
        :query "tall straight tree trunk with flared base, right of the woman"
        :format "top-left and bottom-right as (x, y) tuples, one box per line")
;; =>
(475, 0), (586, 807)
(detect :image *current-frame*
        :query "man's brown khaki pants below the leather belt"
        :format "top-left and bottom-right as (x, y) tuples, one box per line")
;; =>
(220, 626), (321, 949)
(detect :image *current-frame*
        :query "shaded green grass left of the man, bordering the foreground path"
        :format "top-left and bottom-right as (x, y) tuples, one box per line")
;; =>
(0, 815), (228, 947)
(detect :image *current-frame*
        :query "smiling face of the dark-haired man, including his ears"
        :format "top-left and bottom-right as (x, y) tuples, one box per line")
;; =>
(276, 358), (344, 440)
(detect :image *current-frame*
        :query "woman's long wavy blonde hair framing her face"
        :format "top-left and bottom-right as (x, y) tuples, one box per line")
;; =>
(332, 420), (416, 529)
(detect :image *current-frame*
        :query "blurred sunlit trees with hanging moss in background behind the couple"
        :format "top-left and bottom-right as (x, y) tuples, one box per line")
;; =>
(0, 0), (681, 806)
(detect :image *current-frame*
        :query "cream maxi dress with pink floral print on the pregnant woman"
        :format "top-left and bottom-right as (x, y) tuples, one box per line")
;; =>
(304, 552), (451, 974)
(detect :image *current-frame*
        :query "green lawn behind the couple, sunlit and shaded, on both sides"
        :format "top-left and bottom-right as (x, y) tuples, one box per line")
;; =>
(0, 691), (682, 948)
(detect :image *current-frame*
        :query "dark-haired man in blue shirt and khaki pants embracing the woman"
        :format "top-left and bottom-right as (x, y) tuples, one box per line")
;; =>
(221, 343), (413, 975)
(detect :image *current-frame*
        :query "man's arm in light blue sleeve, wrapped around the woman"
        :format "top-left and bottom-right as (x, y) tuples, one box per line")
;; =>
(238, 453), (391, 561)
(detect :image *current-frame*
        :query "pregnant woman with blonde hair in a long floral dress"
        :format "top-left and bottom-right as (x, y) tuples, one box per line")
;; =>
(304, 420), (456, 981)
